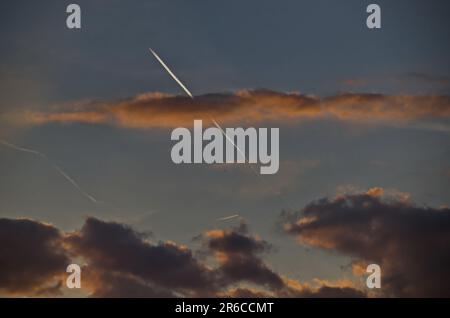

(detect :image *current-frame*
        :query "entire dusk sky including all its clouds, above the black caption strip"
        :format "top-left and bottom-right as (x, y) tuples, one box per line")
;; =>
(0, 0), (450, 297)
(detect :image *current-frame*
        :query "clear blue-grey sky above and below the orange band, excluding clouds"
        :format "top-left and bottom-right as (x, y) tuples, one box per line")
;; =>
(0, 0), (450, 296)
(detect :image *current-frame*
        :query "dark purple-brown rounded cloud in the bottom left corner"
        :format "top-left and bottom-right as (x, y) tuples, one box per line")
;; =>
(0, 218), (70, 296)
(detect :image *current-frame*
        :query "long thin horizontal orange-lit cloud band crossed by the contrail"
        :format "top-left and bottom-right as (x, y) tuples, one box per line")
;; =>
(26, 90), (450, 129)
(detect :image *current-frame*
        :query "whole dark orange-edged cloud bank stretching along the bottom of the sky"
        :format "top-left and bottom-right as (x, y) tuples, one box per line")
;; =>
(0, 188), (450, 297)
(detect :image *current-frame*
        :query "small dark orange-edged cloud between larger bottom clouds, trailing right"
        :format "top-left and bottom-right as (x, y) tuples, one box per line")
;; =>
(197, 222), (365, 298)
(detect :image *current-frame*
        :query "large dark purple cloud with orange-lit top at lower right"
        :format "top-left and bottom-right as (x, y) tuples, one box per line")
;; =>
(284, 188), (450, 297)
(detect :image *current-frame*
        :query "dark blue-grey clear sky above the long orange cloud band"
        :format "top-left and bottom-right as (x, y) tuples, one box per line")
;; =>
(0, 0), (450, 108)
